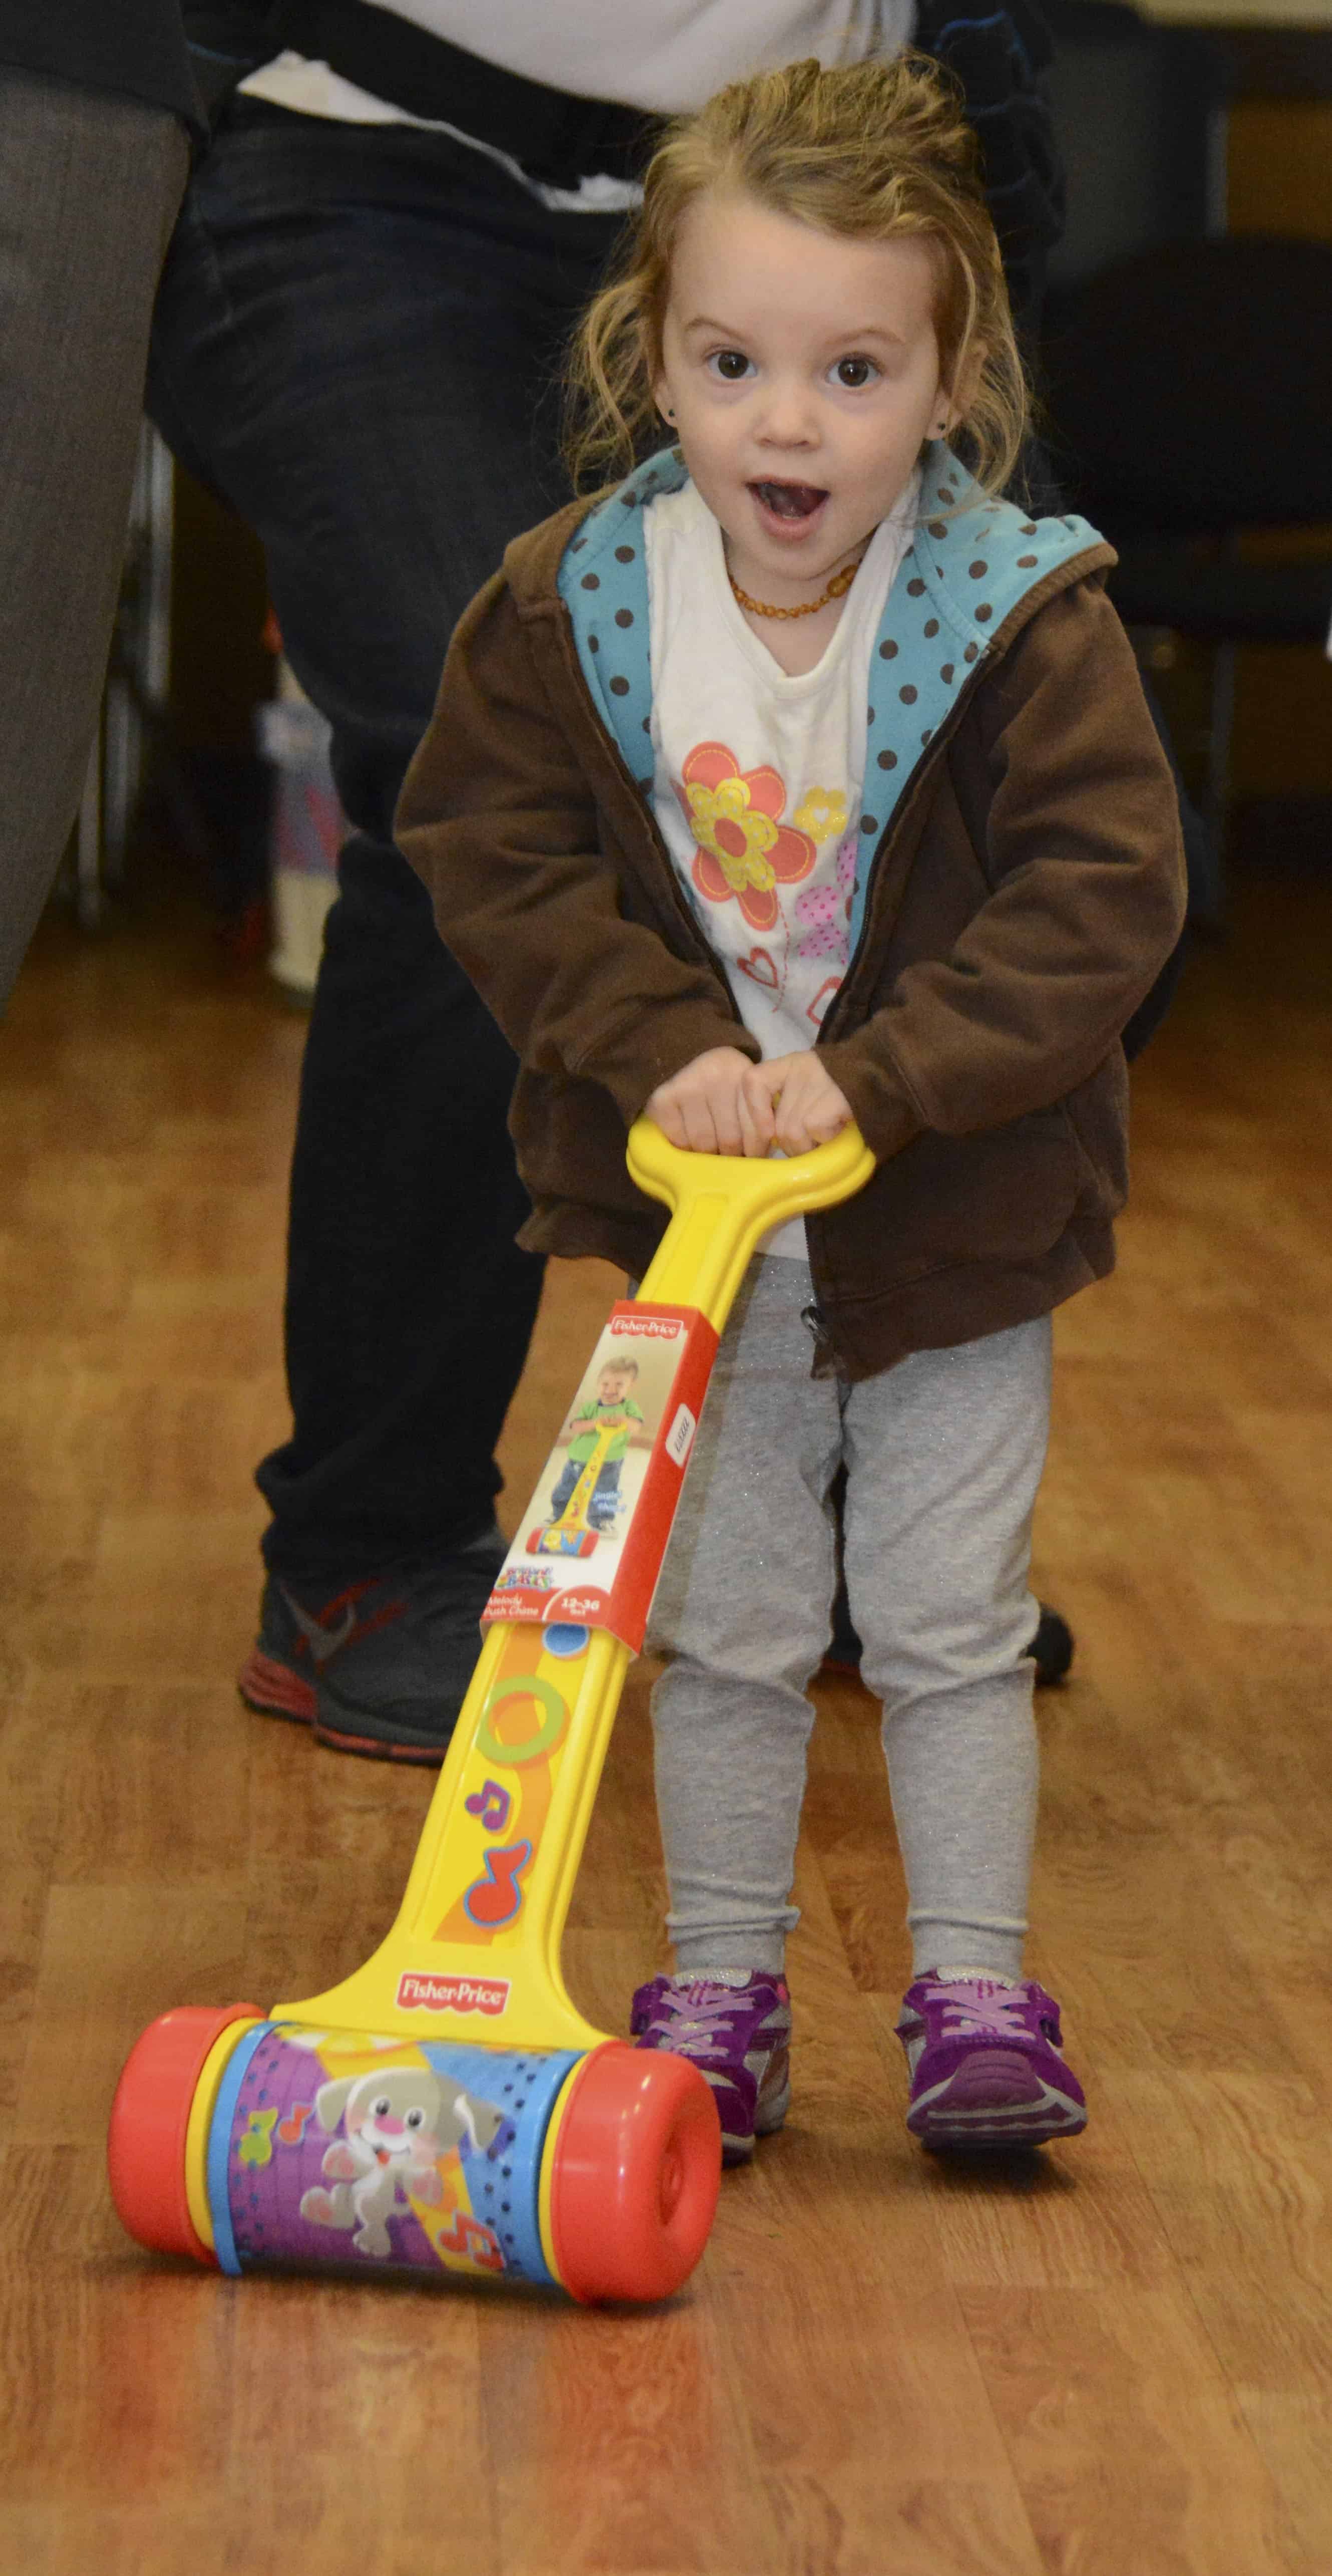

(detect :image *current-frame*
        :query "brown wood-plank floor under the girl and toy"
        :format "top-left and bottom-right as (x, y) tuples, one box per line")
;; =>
(0, 884), (1332, 2576)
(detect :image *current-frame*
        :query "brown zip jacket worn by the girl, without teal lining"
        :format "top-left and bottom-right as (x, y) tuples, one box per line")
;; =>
(397, 476), (1185, 1378)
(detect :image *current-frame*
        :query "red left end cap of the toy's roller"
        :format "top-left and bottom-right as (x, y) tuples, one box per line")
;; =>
(106, 2004), (263, 2269)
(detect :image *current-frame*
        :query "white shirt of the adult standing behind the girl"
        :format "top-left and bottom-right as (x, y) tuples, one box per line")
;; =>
(242, 0), (914, 214)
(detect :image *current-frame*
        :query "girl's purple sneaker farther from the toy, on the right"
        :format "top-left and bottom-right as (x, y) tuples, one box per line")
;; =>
(896, 1976), (1087, 2146)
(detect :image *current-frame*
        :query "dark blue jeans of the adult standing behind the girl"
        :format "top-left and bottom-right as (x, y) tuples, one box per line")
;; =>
(149, 101), (618, 1582)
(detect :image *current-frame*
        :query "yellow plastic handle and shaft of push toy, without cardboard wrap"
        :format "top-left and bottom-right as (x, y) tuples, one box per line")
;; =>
(273, 1120), (873, 2051)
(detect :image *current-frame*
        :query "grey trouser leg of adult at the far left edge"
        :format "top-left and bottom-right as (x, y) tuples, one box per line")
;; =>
(0, 70), (188, 1010)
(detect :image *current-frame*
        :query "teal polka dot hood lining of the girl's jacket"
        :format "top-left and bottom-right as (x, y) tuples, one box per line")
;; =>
(559, 440), (1103, 956)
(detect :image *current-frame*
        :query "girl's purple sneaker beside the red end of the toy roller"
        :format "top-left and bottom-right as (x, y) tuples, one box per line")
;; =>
(628, 1968), (791, 2164)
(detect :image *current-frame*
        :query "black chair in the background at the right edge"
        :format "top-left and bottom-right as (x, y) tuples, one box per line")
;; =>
(1044, 234), (1332, 891)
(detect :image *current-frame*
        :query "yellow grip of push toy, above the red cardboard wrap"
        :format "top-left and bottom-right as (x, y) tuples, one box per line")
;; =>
(628, 1118), (873, 1332)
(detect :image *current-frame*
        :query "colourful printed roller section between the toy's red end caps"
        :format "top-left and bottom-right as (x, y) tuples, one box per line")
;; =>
(209, 2025), (574, 2282)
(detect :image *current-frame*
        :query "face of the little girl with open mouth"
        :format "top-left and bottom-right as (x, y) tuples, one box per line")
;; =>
(654, 196), (953, 606)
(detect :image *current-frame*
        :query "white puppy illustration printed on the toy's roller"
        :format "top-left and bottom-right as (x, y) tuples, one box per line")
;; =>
(301, 2066), (505, 2262)
